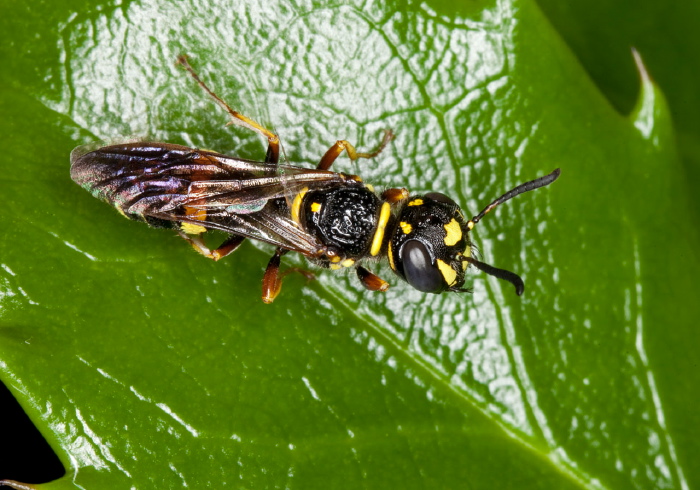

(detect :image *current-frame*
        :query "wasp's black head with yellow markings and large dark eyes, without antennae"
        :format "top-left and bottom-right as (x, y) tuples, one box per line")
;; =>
(389, 192), (470, 293)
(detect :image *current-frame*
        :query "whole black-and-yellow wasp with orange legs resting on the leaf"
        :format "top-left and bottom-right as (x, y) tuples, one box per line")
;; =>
(71, 56), (560, 303)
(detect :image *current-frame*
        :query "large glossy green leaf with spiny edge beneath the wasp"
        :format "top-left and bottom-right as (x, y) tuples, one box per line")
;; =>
(0, 0), (700, 489)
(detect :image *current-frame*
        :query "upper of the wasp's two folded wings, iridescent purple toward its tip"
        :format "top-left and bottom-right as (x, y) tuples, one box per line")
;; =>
(71, 143), (348, 215)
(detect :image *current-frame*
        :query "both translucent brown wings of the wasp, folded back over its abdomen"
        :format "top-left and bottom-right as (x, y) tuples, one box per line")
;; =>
(71, 143), (348, 255)
